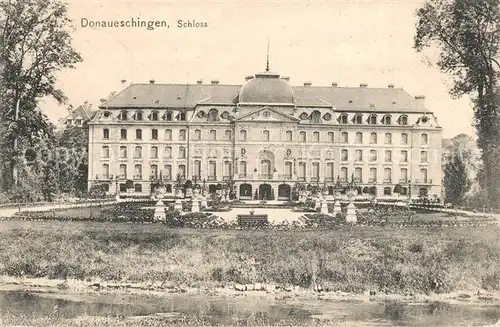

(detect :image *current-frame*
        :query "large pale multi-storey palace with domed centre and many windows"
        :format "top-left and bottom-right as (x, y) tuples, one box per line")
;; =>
(88, 68), (442, 200)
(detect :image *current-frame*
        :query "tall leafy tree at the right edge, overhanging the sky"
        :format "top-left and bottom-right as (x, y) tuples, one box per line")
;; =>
(414, 0), (500, 206)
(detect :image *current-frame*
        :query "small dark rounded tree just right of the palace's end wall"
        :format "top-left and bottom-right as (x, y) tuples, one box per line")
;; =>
(444, 152), (471, 205)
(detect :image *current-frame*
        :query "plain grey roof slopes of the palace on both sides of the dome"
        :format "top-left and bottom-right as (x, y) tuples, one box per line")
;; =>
(100, 83), (430, 113)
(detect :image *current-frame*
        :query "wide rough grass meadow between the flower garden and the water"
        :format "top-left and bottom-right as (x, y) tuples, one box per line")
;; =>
(0, 221), (500, 293)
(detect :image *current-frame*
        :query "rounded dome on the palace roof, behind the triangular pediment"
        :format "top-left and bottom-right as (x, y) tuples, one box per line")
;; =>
(239, 71), (294, 104)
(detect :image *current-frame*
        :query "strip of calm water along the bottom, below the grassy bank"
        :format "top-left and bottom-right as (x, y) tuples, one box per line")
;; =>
(0, 291), (500, 327)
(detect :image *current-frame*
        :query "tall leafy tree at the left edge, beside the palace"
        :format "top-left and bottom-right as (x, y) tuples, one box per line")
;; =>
(0, 0), (82, 189)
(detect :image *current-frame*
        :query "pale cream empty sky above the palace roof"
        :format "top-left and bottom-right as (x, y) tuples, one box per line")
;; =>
(42, 0), (475, 138)
